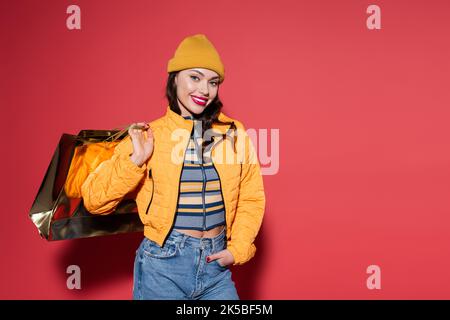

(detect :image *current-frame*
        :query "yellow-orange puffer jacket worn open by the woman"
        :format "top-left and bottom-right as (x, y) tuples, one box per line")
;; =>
(81, 107), (266, 265)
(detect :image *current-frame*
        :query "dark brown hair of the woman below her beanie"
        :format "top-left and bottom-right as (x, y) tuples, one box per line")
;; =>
(166, 71), (236, 154)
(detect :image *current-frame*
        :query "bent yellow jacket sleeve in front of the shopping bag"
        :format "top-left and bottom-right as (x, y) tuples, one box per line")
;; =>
(81, 136), (146, 214)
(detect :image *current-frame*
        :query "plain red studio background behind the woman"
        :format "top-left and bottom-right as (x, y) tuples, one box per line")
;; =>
(0, 0), (450, 299)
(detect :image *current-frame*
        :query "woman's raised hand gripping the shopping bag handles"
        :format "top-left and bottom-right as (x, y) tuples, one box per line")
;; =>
(128, 122), (153, 167)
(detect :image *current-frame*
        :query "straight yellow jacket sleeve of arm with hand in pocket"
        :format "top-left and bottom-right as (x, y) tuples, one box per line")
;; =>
(227, 124), (266, 265)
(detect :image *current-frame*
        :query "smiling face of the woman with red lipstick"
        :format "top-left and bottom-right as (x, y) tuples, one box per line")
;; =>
(175, 68), (219, 116)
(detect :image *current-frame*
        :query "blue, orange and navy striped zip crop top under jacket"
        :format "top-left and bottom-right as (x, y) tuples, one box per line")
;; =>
(174, 116), (225, 231)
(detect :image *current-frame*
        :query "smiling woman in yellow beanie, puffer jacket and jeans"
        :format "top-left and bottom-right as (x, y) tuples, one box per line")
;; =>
(82, 34), (265, 300)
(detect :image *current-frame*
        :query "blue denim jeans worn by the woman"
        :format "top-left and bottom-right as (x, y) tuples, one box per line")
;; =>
(133, 228), (239, 300)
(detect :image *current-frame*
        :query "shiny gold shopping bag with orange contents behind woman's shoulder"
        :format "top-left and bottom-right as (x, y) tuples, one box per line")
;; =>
(29, 128), (143, 241)
